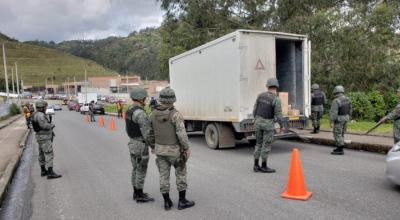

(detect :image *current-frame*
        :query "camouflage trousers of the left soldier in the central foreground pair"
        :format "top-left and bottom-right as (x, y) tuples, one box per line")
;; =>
(128, 141), (149, 189)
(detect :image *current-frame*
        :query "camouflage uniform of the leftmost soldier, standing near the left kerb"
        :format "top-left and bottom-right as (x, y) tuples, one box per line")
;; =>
(32, 111), (55, 167)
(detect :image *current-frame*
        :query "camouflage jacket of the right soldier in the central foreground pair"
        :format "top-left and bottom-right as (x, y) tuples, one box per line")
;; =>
(154, 105), (190, 156)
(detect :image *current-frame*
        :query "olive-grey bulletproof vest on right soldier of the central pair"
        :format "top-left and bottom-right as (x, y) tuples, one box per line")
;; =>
(151, 108), (178, 145)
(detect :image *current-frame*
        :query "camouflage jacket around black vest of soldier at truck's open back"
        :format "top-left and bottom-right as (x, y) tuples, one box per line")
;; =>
(253, 91), (282, 130)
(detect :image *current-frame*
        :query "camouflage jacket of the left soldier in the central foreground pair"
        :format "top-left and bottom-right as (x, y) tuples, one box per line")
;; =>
(129, 103), (154, 147)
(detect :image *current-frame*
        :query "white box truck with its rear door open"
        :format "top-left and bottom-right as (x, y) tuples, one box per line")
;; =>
(169, 30), (311, 148)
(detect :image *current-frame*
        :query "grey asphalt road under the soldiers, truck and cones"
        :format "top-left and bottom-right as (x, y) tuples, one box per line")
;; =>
(0, 111), (400, 220)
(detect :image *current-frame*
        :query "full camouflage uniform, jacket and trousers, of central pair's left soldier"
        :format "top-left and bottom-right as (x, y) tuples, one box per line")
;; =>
(128, 104), (154, 189)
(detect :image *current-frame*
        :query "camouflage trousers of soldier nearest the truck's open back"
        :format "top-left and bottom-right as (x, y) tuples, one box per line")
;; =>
(254, 128), (274, 162)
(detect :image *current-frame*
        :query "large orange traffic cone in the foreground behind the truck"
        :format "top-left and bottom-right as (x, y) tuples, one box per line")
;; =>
(281, 148), (312, 201)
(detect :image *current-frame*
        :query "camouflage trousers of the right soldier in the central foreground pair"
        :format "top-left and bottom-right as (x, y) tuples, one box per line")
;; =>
(156, 155), (187, 193)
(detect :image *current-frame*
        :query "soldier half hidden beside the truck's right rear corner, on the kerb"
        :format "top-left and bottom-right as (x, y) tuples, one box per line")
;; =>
(311, 84), (326, 134)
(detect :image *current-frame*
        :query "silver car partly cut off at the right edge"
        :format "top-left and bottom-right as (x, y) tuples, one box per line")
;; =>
(386, 142), (400, 186)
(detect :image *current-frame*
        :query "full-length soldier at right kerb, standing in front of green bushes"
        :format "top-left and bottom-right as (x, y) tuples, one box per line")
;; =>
(330, 86), (352, 155)
